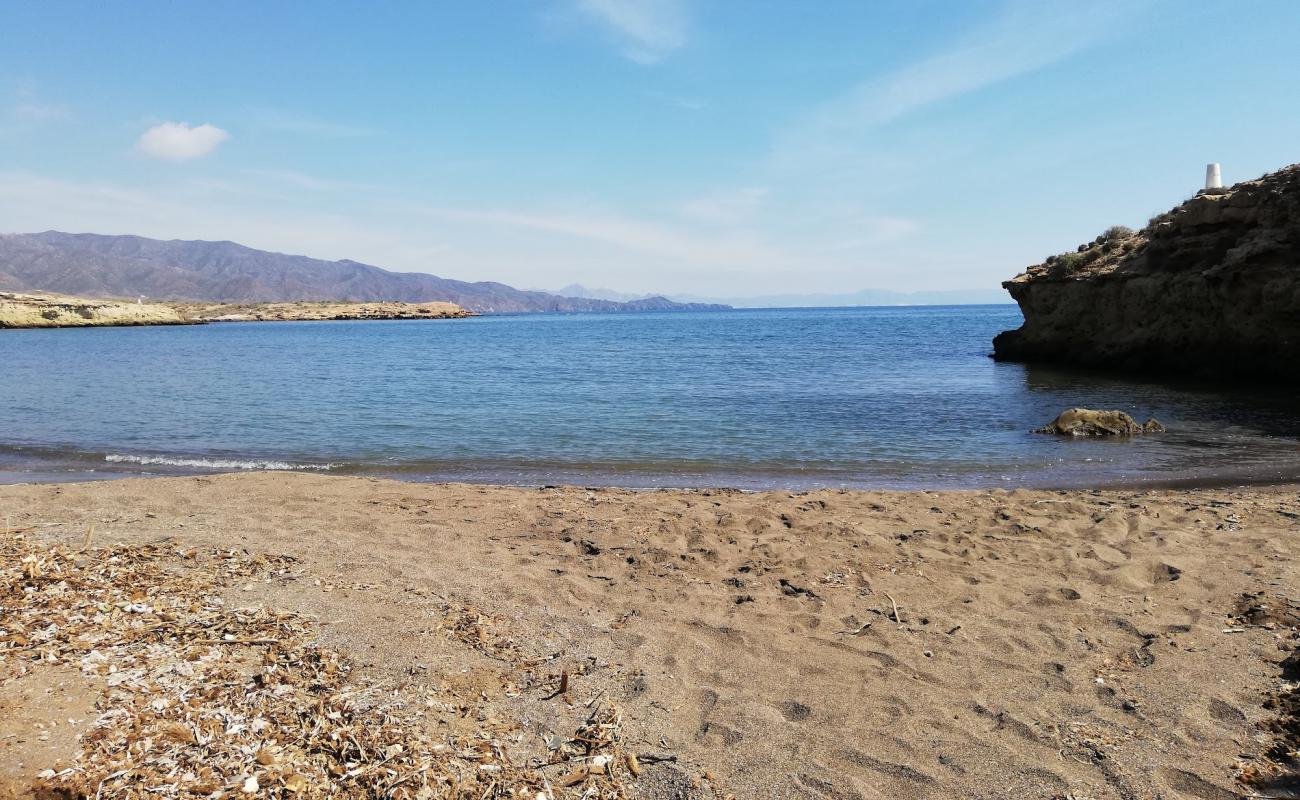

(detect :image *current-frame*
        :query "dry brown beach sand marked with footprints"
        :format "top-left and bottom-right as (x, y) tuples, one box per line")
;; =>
(0, 473), (1300, 800)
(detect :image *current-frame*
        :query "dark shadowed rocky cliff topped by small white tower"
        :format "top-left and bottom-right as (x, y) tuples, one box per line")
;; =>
(993, 164), (1300, 384)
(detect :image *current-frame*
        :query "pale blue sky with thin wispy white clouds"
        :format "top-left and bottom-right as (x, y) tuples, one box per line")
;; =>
(0, 0), (1300, 297)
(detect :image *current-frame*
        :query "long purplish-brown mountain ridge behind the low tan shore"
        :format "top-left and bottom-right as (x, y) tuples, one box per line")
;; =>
(0, 230), (725, 313)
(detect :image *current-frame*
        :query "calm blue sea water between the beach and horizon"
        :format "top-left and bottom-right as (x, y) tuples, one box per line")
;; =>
(0, 306), (1300, 488)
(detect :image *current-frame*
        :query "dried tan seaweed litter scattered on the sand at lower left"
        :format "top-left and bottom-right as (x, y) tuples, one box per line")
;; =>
(0, 531), (641, 800)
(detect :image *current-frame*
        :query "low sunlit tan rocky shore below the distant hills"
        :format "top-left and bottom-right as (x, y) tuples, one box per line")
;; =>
(0, 293), (476, 328)
